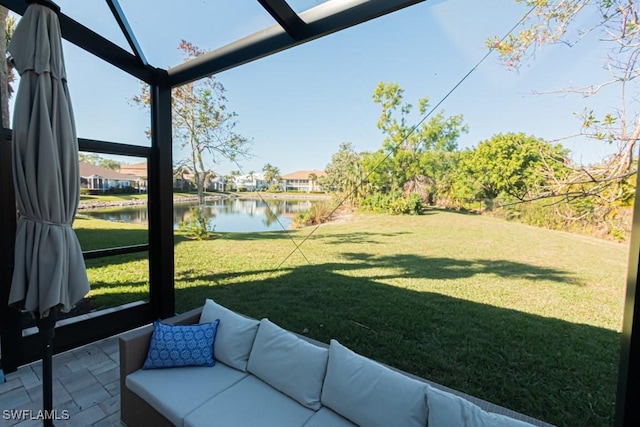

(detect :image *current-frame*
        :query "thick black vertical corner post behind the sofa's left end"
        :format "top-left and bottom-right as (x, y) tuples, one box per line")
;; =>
(147, 78), (175, 319)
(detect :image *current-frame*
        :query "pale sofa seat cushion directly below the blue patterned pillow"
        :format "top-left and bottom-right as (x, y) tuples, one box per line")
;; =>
(125, 363), (248, 425)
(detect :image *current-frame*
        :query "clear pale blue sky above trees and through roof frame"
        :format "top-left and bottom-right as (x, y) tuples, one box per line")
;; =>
(8, 0), (617, 174)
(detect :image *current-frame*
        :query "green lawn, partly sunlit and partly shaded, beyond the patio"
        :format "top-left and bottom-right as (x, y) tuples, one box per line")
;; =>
(75, 211), (628, 426)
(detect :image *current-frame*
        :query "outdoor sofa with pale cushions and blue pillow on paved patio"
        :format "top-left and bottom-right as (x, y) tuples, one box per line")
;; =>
(120, 300), (549, 427)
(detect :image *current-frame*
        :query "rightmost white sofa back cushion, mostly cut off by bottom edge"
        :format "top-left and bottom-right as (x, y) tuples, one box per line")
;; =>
(426, 385), (532, 427)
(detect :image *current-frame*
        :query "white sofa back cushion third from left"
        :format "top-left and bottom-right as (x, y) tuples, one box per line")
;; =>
(322, 340), (428, 427)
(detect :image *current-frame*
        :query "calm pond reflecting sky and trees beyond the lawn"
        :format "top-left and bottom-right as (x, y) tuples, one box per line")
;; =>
(82, 198), (316, 233)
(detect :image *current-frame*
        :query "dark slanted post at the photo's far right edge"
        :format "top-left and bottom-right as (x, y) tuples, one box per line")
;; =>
(615, 162), (640, 427)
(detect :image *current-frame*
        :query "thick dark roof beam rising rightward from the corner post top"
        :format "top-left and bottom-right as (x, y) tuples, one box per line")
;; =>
(167, 0), (425, 87)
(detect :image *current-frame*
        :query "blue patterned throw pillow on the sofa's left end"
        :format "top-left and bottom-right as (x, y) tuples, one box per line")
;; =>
(142, 319), (220, 369)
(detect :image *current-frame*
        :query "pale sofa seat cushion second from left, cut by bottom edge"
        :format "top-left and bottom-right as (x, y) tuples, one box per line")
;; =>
(183, 375), (314, 427)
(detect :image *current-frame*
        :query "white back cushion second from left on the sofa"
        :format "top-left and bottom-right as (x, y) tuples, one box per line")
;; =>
(247, 319), (329, 411)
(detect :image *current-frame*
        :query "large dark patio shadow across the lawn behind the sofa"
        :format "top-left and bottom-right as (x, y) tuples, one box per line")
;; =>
(170, 257), (620, 426)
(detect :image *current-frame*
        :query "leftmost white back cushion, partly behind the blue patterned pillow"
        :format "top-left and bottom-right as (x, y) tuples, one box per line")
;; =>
(200, 299), (260, 372)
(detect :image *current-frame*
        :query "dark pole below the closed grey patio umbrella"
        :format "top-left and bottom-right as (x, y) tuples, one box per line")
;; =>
(37, 308), (58, 427)
